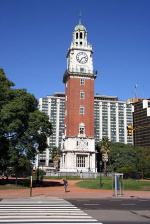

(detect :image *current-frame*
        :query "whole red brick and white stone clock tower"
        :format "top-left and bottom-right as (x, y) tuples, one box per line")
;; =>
(60, 22), (96, 172)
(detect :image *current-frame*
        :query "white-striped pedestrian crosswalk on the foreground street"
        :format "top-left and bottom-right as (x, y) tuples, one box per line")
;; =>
(0, 197), (102, 224)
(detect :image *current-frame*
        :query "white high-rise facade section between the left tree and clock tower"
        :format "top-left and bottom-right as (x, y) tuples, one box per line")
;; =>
(36, 93), (65, 167)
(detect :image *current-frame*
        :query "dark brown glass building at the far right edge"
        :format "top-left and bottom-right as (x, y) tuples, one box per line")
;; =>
(133, 99), (150, 147)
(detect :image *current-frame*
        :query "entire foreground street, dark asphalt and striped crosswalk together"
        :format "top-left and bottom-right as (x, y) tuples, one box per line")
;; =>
(0, 196), (150, 224)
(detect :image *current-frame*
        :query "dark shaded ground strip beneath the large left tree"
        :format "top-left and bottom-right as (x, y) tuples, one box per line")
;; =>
(0, 178), (63, 189)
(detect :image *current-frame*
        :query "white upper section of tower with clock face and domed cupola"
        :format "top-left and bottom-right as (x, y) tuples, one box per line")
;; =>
(64, 21), (93, 75)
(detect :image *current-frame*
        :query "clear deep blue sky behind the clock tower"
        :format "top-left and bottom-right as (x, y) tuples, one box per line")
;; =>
(0, 0), (150, 100)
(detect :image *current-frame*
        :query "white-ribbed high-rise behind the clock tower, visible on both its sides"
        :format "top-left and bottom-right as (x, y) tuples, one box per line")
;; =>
(39, 93), (133, 166)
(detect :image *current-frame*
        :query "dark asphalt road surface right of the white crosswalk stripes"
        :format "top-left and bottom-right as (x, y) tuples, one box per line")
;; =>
(68, 198), (150, 224)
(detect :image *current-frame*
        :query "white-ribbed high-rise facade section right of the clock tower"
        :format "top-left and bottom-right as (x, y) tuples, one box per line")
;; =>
(94, 95), (133, 144)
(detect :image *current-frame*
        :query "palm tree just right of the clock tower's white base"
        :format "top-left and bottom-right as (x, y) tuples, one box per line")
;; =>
(100, 137), (111, 176)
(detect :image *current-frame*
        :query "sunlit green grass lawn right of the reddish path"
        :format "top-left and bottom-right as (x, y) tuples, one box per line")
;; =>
(77, 177), (150, 191)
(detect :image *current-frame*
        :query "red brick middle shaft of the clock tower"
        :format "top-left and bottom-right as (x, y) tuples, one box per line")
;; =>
(65, 78), (94, 137)
